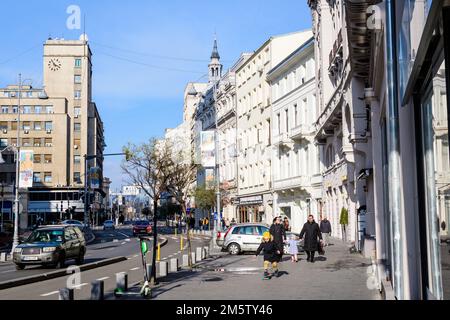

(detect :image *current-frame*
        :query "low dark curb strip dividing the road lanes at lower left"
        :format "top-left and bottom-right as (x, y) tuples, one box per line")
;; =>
(0, 257), (127, 290)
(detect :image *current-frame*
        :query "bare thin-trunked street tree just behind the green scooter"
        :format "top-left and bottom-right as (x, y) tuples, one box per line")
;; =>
(122, 139), (173, 284)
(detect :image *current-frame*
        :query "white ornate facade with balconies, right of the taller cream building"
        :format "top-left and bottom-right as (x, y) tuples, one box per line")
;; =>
(268, 38), (322, 233)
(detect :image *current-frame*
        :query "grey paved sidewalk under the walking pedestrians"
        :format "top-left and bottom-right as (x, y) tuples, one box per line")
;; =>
(128, 240), (381, 300)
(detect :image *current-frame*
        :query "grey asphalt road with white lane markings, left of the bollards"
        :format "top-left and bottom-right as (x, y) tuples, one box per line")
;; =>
(0, 228), (209, 300)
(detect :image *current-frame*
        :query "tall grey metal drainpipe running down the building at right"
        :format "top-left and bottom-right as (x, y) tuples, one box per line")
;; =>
(386, 0), (405, 300)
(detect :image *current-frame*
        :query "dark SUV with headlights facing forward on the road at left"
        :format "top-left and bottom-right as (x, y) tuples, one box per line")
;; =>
(13, 225), (86, 270)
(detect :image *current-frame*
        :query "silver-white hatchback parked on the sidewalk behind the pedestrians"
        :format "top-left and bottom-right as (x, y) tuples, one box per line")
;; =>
(222, 223), (269, 255)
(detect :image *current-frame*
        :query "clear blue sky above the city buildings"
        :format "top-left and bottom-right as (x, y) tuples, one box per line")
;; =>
(0, 0), (311, 188)
